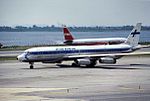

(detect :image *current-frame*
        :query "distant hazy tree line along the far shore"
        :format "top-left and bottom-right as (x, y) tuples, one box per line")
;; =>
(0, 25), (150, 32)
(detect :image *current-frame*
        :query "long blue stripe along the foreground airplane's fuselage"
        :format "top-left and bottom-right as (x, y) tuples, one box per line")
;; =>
(30, 48), (130, 55)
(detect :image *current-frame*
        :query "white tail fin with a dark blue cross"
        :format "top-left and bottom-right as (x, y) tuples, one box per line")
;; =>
(125, 23), (142, 48)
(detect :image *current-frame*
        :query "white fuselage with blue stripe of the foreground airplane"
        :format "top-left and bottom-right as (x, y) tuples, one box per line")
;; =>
(18, 44), (131, 62)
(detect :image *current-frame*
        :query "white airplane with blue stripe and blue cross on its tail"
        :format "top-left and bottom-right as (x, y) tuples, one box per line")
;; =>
(17, 23), (150, 69)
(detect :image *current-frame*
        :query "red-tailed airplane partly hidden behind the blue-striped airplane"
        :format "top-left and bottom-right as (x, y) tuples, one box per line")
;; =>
(62, 25), (127, 45)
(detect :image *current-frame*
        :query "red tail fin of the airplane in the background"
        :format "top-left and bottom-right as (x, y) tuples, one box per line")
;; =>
(63, 26), (74, 41)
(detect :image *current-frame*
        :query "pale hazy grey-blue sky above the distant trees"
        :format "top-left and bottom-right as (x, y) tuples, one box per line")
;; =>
(0, 0), (150, 26)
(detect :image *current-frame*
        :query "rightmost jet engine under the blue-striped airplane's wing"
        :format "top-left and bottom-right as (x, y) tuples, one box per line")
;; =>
(99, 57), (116, 64)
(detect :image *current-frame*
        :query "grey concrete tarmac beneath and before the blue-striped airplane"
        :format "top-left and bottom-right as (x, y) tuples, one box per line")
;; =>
(0, 50), (150, 101)
